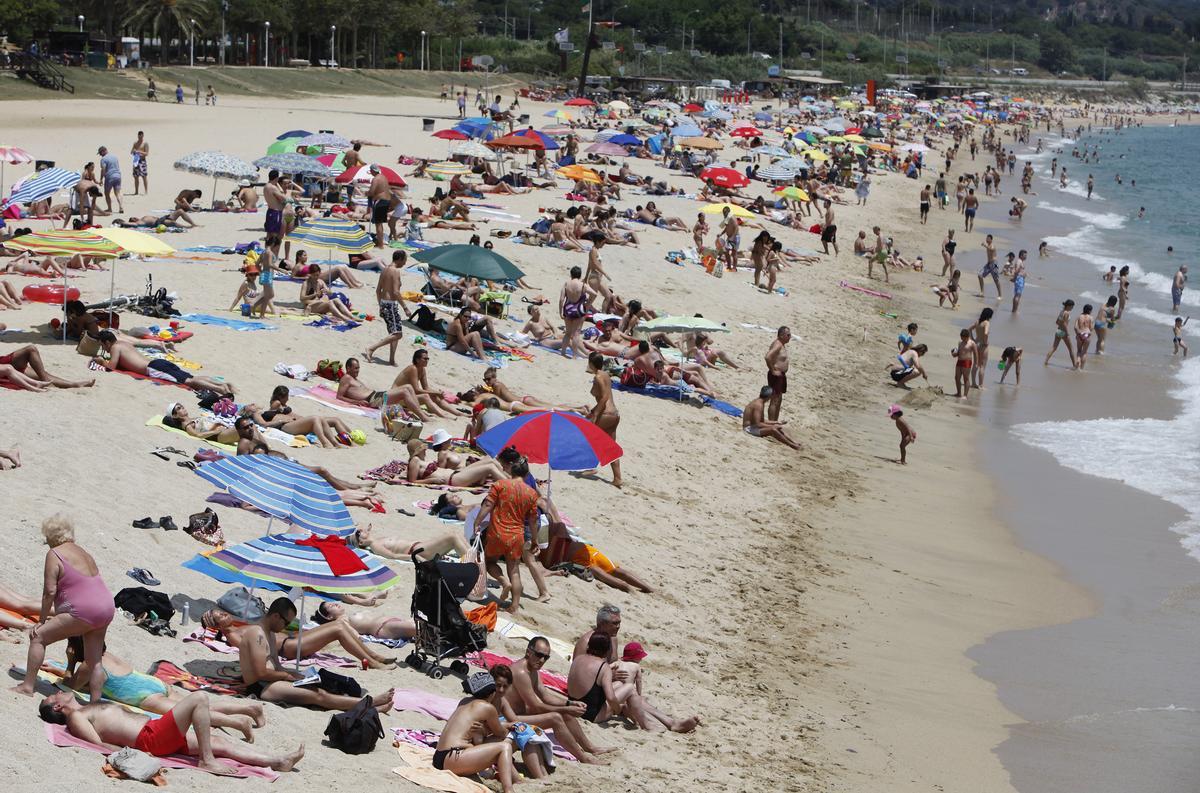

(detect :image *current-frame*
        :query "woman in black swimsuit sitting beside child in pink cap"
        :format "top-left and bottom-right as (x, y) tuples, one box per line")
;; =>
(566, 632), (701, 733)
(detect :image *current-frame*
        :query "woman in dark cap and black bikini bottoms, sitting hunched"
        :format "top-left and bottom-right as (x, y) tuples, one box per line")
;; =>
(433, 672), (518, 793)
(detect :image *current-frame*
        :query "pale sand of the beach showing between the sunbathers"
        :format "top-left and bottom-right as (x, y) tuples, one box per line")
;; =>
(0, 83), (1132, 792)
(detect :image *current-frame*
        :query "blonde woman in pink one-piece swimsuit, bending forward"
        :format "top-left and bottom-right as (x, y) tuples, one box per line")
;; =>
(13, 515), (116, 702)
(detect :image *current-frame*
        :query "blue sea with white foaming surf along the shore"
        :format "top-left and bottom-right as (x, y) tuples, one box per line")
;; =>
(1012, 126), (1200, 560)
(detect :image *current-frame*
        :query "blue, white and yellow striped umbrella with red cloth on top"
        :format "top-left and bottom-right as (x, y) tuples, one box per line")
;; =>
(202, 532), (400, 594)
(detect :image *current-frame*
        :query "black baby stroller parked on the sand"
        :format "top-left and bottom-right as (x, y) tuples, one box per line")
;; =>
(407, 554), (487, 680)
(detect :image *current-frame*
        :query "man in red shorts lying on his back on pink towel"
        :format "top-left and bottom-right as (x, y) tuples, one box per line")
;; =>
(38, 691), (304, 776)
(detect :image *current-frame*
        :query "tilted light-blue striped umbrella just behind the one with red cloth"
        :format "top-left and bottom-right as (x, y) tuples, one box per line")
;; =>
(196, 455), (354, 536)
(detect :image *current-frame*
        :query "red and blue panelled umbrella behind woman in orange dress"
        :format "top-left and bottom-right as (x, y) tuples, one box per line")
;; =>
(475, 410), (624, 470)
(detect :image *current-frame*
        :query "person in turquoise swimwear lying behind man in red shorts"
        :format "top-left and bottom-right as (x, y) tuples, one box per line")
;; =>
(42, 636), (266, 743)
